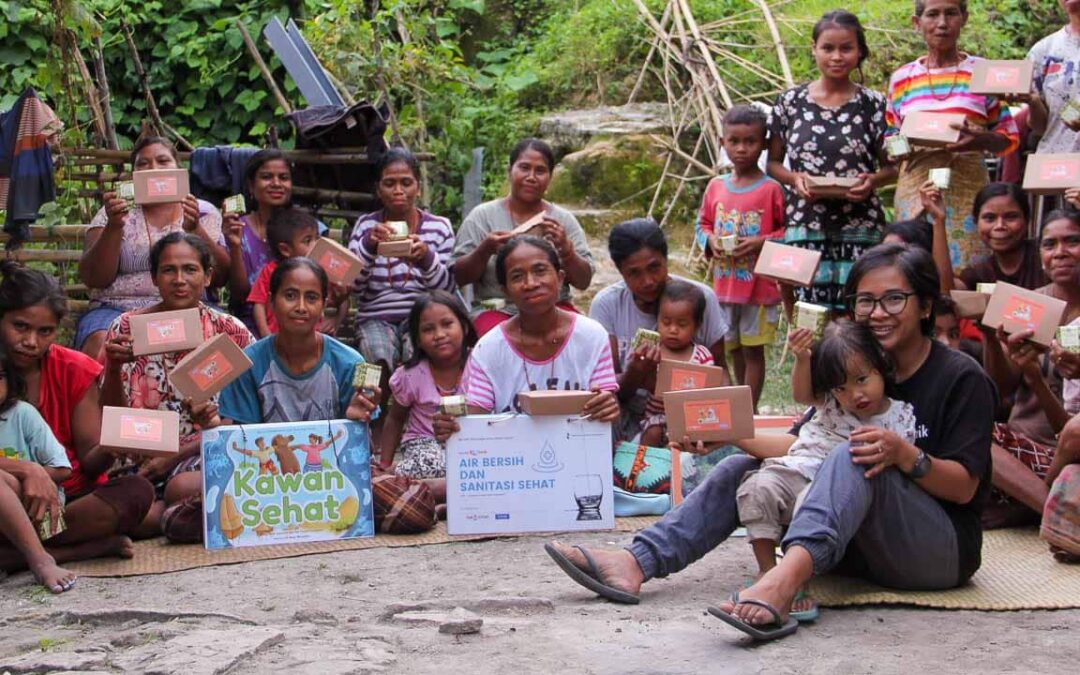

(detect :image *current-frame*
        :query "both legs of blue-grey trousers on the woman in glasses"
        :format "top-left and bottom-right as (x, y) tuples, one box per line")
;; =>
(627, 444), (960, 589)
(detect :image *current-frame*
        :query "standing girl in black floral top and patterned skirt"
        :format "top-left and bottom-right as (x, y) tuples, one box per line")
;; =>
(769, 10), (896, 312)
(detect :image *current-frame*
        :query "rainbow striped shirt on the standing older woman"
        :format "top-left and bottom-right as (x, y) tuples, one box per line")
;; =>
(885, 56), (1020, 156)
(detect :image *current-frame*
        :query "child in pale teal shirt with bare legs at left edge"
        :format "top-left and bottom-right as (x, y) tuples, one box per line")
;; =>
(0, 350), (76, 593)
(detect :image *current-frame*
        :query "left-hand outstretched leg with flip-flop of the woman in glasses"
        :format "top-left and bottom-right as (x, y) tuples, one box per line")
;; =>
(552, 455), (759, 595)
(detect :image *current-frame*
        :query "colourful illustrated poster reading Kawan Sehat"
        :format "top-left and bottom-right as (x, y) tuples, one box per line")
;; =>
(202, 420), (375, 550)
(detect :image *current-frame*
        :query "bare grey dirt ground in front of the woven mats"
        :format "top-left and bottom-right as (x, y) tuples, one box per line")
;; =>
(0, 534), (1080, 675)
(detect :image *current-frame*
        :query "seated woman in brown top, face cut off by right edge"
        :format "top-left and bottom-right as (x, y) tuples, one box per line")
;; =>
(984, 211), (1080, 527)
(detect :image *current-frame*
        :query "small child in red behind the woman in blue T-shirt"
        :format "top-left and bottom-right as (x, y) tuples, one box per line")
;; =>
(247, 206), (349, 338)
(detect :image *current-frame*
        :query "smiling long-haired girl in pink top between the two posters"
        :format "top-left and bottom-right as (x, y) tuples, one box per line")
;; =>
(379, 291), (477, 502)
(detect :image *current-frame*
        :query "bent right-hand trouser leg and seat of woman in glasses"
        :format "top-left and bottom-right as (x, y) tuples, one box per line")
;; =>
(783, 443), (963, 590)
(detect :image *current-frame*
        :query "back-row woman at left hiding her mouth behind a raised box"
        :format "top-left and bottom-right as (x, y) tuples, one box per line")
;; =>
(75, 136), (229, 359)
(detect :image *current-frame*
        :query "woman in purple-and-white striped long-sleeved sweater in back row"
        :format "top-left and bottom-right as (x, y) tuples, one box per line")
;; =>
(349, 148), (454, 391)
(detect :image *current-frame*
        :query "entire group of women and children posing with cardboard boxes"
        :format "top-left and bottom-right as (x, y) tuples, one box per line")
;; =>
(0, 0), (1080, 637)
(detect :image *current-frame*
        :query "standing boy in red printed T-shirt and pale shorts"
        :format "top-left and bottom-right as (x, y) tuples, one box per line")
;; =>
(701, 106), (784, 409)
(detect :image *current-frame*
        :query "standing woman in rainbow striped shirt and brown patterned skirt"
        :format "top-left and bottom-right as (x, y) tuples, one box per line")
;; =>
(886, 0), (1020, 270)
